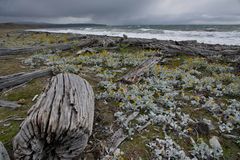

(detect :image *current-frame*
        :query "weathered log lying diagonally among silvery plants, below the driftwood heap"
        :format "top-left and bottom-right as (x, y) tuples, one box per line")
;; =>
(120, 58), (161, 84)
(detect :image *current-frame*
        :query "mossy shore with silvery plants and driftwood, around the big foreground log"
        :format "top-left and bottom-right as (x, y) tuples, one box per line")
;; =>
(0, 25), (240, 160)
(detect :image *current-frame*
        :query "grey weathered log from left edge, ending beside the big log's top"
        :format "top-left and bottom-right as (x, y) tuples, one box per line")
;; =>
(0, 68), (52, 90)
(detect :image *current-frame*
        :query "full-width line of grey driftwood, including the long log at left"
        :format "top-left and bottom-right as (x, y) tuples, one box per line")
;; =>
(0, 33), (240, 63)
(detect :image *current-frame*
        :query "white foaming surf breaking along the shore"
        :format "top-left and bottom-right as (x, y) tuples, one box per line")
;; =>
(29, 28), (240, 45)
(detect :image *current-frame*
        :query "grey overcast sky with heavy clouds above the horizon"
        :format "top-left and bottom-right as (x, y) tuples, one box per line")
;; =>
(0, 0), (240, 24)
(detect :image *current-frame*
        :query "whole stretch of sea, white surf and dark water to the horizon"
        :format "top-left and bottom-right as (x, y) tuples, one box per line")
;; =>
(27, 25), (240, 45)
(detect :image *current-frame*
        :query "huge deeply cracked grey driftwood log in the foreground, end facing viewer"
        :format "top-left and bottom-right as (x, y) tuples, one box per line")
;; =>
(13, 74), (94, 160)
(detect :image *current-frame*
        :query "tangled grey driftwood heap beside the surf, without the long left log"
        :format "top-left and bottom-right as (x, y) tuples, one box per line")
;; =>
(72, 35), (240, 63)
